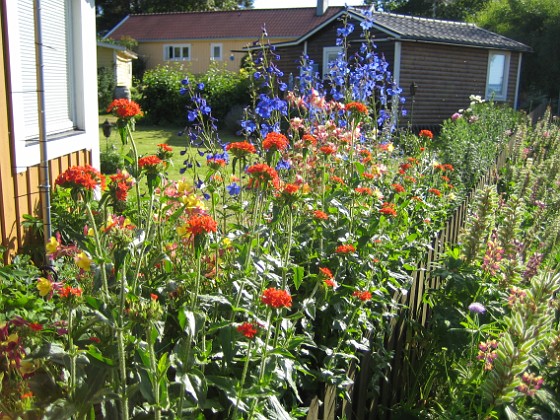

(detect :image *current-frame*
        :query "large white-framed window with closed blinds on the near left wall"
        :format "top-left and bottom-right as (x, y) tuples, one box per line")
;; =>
(5, 0), (98, 172)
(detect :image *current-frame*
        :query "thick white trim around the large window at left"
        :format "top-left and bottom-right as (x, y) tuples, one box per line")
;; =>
(5, 0), (99, 173)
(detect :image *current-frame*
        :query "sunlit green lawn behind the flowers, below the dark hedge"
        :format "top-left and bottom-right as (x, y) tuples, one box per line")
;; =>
(99, 114), (241, 180)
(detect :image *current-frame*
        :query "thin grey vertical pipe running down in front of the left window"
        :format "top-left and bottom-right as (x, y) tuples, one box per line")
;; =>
(33, 0), (52, 266)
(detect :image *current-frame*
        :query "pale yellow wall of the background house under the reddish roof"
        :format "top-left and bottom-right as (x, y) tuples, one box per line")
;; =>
(138, 38), (289, 74)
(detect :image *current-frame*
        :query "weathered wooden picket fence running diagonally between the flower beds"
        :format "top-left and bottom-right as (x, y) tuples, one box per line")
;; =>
(307, 138), (516, 420)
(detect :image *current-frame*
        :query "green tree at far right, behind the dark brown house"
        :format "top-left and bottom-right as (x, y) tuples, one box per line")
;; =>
(475, 0), (560, 101)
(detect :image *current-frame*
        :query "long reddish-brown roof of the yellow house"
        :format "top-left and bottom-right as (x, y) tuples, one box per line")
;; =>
(105, 7), (344, 42)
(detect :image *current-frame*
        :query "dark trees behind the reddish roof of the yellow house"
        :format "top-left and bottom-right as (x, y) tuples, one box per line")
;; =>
(96, 0), (253, 34)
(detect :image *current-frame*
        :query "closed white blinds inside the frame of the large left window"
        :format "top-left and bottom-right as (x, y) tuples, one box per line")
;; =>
(8, 0), (76, 141)
